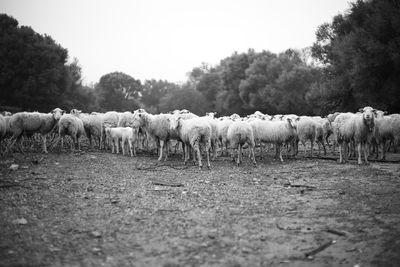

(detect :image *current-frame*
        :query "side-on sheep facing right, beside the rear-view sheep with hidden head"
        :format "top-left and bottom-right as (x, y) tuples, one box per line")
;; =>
(250, 118), (297, 162)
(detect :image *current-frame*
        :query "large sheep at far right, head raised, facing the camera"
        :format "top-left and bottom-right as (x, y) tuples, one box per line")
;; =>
(333, 107), (376, 164)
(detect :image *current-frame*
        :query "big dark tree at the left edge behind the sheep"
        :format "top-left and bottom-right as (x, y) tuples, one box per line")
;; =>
(0, 14), (69, 111)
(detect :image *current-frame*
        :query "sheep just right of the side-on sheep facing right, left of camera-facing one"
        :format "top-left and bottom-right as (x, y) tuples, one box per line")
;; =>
(296, 116), (322, 157)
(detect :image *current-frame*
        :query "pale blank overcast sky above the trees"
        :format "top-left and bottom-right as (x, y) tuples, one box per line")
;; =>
(0, 0), (351, 83)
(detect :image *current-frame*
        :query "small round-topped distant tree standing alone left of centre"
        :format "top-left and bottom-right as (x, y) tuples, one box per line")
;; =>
(96, 72), (142, 111)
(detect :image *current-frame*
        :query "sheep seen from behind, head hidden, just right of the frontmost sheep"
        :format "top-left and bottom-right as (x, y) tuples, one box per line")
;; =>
(227, 121), (257, 165)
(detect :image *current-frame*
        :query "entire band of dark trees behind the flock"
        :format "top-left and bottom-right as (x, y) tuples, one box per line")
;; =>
(0, 0), (400, 115)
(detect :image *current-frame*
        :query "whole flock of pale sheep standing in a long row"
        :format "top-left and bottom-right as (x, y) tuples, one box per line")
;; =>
(0, 107), (400, 168)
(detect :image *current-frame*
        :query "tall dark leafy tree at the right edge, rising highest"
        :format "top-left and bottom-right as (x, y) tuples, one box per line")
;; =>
(312, 0), (400, 112)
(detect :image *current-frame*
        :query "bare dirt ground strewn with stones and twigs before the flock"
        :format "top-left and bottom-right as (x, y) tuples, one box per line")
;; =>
(0, 150), (400, 266)
